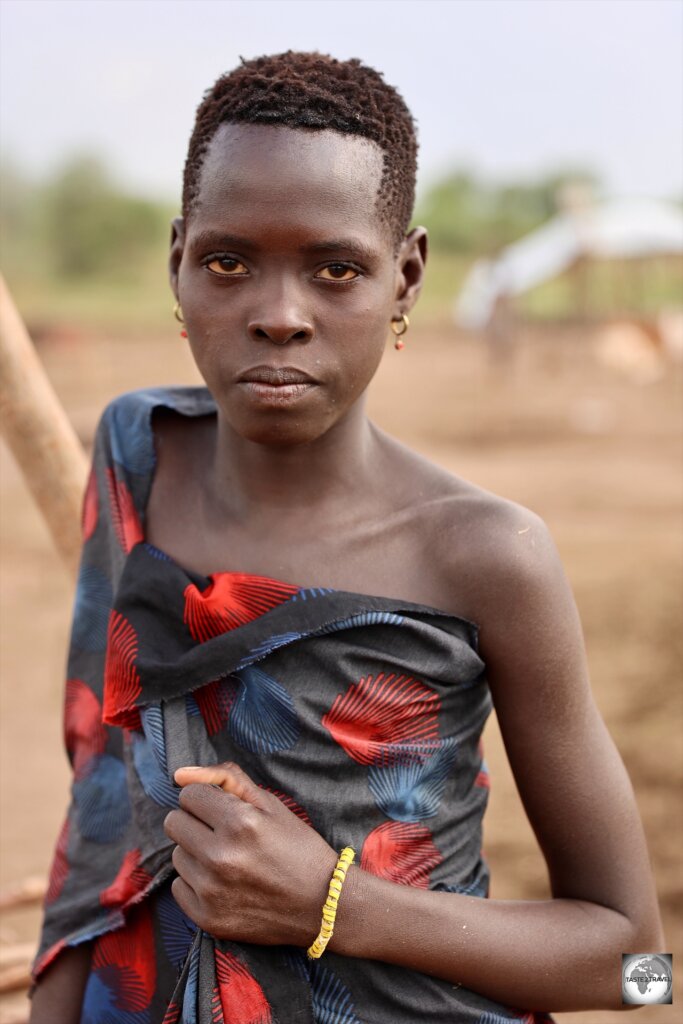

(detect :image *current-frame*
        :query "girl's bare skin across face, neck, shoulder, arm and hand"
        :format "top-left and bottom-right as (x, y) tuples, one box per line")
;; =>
(32, 126), (663, 1024)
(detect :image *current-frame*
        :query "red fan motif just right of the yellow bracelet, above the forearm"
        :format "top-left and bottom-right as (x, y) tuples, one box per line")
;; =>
(360, 821), (443, 889)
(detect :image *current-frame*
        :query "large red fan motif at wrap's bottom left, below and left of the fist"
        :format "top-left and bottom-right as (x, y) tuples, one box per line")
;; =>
(92, 905), (157, 1013)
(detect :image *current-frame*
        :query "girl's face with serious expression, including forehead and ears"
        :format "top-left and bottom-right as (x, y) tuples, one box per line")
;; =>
(171, 125), (425, 444)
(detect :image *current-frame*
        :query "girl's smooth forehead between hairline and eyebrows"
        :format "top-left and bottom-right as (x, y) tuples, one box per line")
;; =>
(190, 124), (388, 238)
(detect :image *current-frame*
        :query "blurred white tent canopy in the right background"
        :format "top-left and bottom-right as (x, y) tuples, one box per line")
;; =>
(455, 199), (683, 330)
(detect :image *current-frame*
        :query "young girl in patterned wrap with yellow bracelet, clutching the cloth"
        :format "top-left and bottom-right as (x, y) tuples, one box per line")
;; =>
(32, 52), (661, 1024)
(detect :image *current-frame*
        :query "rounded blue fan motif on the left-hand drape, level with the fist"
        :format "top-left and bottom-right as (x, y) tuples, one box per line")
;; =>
(73, 754), (130, 843)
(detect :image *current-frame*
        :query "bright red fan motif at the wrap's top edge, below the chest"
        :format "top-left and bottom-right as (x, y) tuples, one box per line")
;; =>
(183, 572), (299, 643)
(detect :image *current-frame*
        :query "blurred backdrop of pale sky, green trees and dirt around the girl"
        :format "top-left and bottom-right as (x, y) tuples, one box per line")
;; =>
(0, 0), (683, 1024)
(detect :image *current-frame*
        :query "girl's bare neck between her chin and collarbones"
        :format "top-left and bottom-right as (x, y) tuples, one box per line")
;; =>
(210, 400), (376, 522)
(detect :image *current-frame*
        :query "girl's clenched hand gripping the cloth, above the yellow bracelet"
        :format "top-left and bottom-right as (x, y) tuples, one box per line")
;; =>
(164, 763), (337, 946)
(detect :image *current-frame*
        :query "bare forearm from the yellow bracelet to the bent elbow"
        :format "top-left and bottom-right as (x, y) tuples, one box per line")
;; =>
(329, 868), (659, 1011)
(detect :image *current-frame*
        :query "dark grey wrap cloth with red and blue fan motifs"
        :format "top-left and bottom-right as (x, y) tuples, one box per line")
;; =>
(35, 388), (549, 1024)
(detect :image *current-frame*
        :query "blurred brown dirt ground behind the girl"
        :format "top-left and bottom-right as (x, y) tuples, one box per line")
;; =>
(0, 319), (683, 1024)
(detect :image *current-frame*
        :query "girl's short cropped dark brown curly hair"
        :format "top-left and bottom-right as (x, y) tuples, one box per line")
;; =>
(182, 50), (418, 246)
